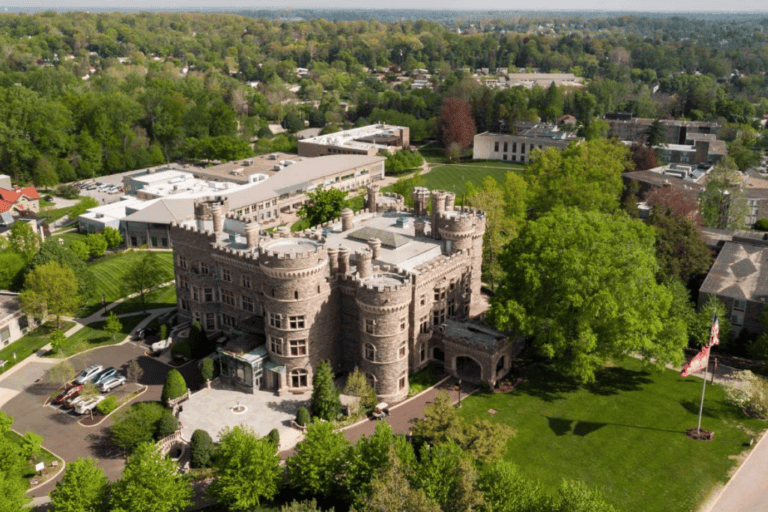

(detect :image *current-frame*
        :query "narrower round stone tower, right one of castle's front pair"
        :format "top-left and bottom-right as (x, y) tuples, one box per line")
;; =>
(355, 272), (411, 402)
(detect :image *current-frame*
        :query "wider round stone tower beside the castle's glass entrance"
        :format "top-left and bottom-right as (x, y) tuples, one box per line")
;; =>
(259, 233), (338, 395)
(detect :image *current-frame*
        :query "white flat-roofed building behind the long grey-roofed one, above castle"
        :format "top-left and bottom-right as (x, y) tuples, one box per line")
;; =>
(299, 124), (410, 157)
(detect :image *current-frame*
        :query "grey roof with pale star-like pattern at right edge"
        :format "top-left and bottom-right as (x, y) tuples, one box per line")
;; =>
(699, 242), (768, 302)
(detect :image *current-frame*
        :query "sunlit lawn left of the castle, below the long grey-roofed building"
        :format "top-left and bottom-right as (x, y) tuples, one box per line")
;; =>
(83, 251), (173, 315)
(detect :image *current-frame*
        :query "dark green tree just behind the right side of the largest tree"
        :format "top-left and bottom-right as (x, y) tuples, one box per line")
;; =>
(648, 207), (712, 283)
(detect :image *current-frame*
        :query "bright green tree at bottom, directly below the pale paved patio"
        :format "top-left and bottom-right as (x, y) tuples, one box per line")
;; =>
(208, 425), (282, 511)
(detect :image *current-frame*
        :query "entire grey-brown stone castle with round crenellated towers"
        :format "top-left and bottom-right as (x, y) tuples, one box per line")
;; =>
(172, 185), (511, 402)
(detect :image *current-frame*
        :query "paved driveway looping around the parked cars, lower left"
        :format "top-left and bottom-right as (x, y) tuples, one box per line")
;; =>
(2, 342), (199, 496)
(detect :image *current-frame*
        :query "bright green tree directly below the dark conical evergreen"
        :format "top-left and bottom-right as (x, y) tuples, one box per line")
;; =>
(286, 420), (349, 498)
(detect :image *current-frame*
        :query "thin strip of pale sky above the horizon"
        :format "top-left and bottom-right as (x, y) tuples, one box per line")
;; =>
(0, 0), (768, 14)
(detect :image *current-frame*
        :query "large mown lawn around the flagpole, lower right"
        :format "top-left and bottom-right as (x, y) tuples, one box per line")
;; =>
(460, 358), (768, 512)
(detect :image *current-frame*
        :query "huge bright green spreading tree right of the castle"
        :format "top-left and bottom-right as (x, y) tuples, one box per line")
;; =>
(489, 208), (687, 382)
